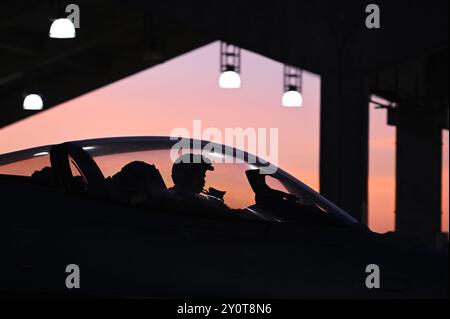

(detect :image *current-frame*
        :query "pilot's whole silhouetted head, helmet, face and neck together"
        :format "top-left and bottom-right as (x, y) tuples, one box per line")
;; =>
(171, 153), (214, 195)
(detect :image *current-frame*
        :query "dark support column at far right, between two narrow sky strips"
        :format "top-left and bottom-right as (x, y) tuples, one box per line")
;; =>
(389, 105), (442, 244)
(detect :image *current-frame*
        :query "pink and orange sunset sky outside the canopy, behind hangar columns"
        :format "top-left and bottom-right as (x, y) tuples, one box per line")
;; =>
(0, 42), (449, 232)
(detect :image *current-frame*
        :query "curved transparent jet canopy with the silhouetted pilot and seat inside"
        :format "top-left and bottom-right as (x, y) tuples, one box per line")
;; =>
(0, 137), (356, 227)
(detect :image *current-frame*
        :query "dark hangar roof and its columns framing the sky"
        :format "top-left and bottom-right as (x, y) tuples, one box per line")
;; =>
(0, 0), (449, 243)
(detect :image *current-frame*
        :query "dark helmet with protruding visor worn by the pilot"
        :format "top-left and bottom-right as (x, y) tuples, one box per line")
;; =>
(172, 153), (214, 186)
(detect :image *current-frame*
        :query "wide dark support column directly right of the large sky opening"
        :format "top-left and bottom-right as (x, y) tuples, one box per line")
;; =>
(320, 69), (369, 224)
